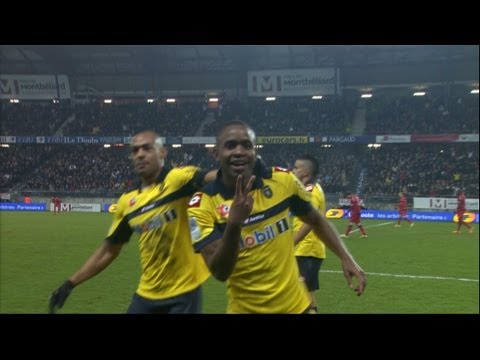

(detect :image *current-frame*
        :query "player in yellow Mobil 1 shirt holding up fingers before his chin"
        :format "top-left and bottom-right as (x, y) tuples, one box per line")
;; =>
(188, 121), (366, 314)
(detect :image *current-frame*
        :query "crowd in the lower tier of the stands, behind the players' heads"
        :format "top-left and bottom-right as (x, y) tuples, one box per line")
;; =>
(0, 143), (479, 196)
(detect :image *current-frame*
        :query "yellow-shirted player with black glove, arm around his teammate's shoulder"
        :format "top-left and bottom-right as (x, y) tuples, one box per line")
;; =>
(50, 131), (216, 314)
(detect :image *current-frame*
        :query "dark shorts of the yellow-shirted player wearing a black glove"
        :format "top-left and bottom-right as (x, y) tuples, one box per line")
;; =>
(127, 286), (202, 314)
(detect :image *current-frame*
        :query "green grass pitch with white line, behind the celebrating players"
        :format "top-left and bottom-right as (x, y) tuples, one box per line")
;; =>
(0, 212), (479, 314)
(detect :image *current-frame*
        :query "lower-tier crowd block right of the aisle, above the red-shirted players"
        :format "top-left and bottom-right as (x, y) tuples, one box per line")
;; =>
(362, 143), (479, 196)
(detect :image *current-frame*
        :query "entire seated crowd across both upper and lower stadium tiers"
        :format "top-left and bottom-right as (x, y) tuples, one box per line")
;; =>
(0, 95), (479, 196)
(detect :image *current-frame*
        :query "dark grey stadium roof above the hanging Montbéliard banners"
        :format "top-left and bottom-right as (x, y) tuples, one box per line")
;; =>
(0, 45), (479, 76)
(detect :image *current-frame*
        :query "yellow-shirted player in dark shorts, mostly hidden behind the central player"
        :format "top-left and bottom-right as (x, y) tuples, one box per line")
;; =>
(292, 154), (325, 313)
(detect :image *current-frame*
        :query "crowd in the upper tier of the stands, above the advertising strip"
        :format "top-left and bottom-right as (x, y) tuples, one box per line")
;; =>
(0, 94), (479, 136)
